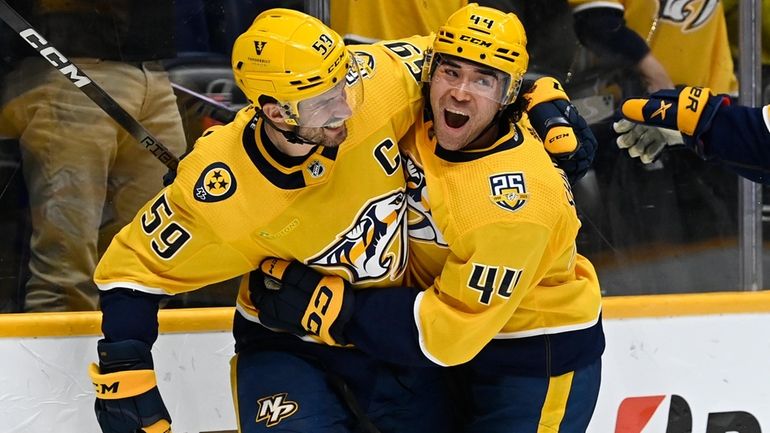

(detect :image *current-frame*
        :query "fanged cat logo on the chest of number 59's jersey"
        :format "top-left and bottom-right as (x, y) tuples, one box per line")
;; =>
(307, 190), (408, 283)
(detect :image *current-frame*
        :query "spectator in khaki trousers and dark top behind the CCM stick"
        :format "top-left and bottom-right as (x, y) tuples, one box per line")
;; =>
(0, 0), (185, 311)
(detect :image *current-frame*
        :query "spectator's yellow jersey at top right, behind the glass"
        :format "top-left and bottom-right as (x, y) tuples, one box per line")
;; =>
(569, 0), (738, 94)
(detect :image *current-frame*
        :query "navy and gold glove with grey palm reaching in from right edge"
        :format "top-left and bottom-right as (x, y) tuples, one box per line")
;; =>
(613, 87), (730, 163)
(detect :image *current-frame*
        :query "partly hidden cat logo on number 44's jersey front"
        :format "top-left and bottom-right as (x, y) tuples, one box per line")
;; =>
(404, 156), (447, 247)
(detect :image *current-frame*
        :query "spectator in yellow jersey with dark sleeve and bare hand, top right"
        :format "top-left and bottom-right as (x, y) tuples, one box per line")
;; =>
(569, 0), (738, 93)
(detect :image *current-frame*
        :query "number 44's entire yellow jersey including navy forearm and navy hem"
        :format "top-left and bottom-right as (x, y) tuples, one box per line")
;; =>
(346, 111), (604, 376)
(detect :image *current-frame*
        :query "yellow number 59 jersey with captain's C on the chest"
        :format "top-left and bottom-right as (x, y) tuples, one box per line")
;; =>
(94, 37), (431, 330)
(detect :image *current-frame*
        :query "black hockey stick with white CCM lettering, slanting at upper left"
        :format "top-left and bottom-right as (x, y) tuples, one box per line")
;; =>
(0, 0), (179, 170)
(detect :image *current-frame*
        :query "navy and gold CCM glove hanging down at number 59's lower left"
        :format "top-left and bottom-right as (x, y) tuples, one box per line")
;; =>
(88, 340), (171, 433)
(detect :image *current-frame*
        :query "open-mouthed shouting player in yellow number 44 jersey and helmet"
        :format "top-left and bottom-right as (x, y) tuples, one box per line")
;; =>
(252, 4), (604, 433)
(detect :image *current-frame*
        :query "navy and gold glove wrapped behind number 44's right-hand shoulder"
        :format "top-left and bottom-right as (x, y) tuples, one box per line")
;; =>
(523, 77), (598, 184)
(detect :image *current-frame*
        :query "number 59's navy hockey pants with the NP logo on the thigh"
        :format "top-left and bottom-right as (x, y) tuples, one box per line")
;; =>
(231, 349), (458, 433)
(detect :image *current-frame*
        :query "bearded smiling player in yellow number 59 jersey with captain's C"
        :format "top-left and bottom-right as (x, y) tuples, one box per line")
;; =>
(90, 9), (460, 433)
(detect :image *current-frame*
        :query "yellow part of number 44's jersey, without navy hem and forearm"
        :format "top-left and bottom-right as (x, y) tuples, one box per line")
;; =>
(402, 113), (601, 365)
